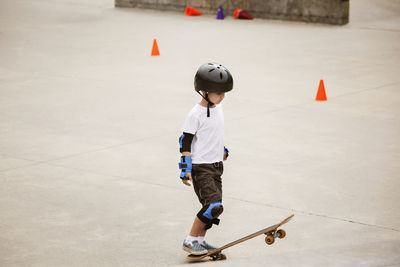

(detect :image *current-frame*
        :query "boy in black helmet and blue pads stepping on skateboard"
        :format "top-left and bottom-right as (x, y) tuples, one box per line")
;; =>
(179, 63), (233, 255)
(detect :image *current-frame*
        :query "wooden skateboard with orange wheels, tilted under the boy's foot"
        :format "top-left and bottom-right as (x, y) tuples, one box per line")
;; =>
(186, 214), (294, 262)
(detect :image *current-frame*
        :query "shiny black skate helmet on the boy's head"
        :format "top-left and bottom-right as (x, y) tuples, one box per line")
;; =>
(194, 63), (233, 93)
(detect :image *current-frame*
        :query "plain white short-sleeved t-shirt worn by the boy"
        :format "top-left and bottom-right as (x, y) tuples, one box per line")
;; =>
(182, 104), (224, 164)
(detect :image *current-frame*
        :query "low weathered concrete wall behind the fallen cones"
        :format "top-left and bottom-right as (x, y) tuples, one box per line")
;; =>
(115, 0), (349, 25)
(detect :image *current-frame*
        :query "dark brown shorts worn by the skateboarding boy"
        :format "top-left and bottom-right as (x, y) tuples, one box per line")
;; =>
(192, 161), (224, 207)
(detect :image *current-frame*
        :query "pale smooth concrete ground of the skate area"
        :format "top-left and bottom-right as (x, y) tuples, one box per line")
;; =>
(0, 0), (400, 266)
